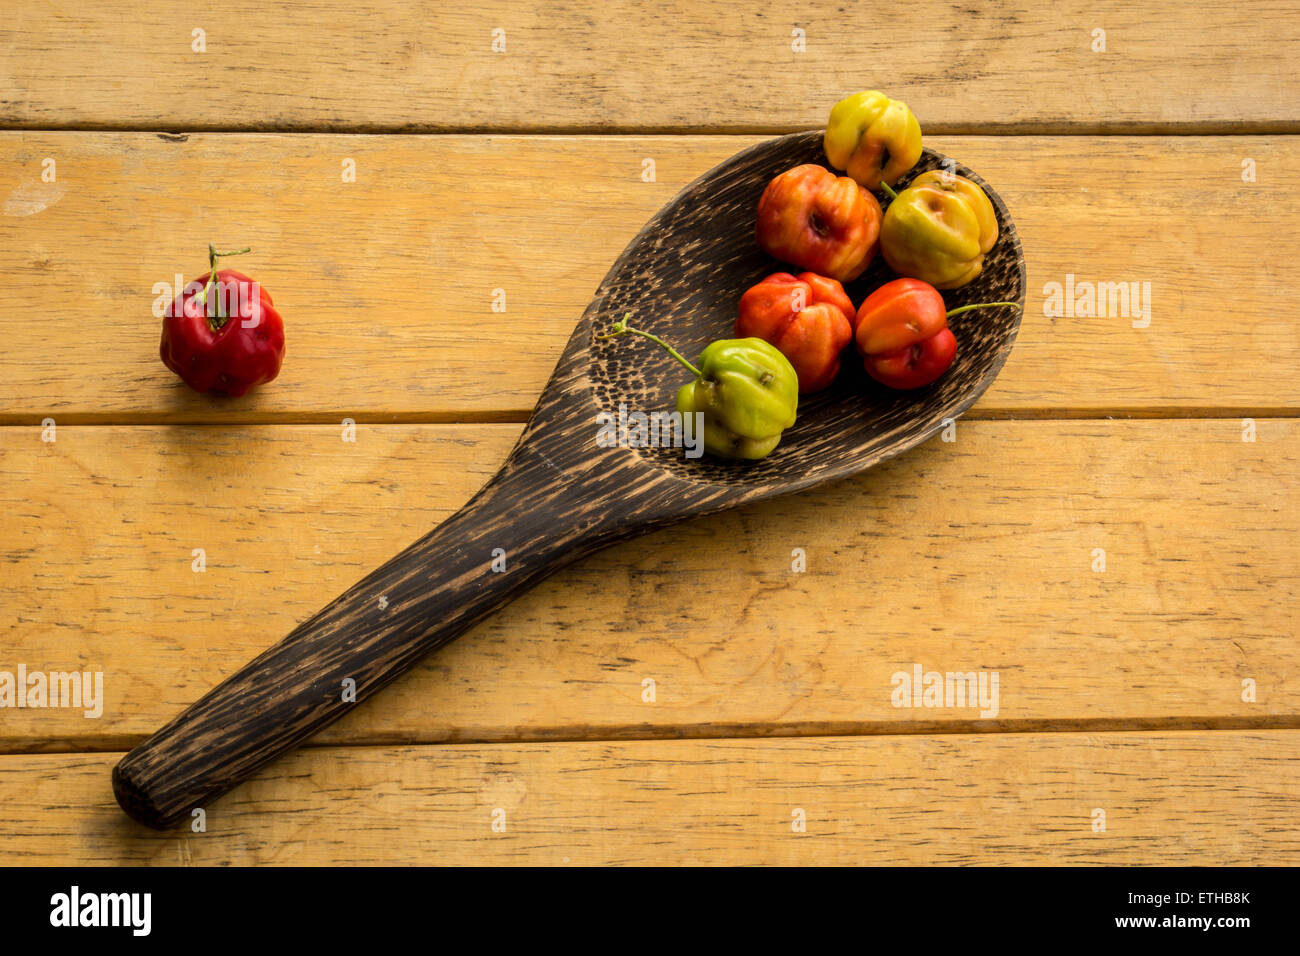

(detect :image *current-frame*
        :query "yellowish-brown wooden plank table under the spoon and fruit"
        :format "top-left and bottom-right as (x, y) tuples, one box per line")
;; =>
(0, 0), (1300, 865)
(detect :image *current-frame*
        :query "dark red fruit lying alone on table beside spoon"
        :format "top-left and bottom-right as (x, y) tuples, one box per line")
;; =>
(159, 246), (285, 395)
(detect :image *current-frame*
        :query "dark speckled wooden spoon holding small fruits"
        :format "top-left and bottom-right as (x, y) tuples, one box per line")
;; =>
(113, 133), (1024, 829)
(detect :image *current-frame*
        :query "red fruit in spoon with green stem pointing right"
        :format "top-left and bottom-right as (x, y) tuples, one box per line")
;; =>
(854, 278), (1019, 389)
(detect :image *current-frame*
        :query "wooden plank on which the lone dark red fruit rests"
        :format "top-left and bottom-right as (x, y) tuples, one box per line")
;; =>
(0, 133), (1300, 424)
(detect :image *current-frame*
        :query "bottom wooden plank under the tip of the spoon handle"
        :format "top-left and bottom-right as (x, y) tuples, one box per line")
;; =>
(10, 731), (1300, 866)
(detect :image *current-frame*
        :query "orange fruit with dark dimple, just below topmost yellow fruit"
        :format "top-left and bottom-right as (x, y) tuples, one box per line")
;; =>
(757, 163), (880, 282)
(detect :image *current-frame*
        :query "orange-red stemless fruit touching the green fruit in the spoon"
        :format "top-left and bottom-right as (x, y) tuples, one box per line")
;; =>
(736, 272), (854, 394)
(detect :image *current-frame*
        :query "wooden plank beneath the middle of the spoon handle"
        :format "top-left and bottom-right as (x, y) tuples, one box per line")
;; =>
(0, 419), (1300, 750)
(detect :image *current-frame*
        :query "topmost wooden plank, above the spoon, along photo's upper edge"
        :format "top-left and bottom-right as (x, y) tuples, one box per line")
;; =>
(0, 0), (1300, 131)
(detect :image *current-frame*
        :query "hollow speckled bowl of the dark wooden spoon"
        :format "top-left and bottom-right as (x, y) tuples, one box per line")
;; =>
(590, 130), (1026, 496)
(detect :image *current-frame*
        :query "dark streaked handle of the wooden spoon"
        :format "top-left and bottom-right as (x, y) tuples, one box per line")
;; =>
(113, 466), (613, 830)
